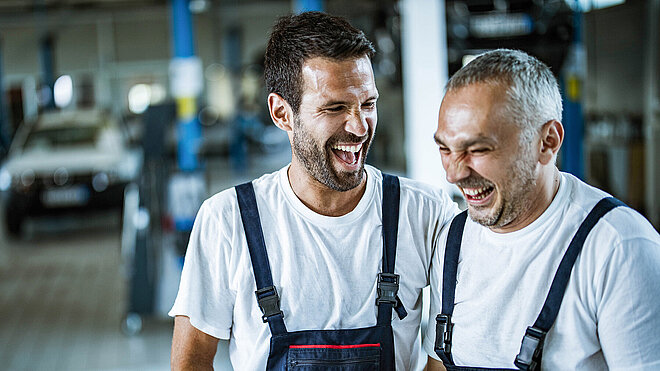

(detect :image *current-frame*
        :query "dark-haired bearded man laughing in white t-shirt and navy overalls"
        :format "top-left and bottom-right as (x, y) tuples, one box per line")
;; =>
(170, 12), (458, 370)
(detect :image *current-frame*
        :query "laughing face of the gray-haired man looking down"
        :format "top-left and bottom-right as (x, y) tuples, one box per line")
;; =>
(435, 83), (539, 230)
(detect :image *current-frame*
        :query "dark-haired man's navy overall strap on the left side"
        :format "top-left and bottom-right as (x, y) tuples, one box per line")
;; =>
(235, 182), (287, 336)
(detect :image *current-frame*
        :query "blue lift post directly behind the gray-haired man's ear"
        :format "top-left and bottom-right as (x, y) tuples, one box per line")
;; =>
(560, 0), (586, 179)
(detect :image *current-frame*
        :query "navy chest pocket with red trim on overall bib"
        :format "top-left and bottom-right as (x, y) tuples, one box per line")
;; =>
(287, 344), (381, 371)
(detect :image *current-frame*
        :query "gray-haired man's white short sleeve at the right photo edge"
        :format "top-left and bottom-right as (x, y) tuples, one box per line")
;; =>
(596, 238), (660, 370)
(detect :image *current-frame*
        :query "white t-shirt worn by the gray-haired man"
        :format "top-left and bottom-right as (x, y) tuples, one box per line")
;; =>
(424, 173), (660, 370)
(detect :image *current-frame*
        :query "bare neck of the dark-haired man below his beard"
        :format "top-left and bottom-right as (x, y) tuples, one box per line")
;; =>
(287, 162), (367, 216)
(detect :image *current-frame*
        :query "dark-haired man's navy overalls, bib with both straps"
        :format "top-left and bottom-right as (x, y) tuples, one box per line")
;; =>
(236, 174), (407, 371)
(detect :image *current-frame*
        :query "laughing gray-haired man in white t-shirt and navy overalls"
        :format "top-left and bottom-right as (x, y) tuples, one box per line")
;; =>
(424, 49), (660, 370)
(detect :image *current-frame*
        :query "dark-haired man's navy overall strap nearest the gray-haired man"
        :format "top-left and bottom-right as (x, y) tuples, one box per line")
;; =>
(376, 173), (408, 325)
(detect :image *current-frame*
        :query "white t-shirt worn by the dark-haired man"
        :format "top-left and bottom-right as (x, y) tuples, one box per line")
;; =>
(169, 166), (458, 370)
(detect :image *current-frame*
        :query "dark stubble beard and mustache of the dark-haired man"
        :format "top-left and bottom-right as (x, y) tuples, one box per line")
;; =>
(292, 117), (372, 192)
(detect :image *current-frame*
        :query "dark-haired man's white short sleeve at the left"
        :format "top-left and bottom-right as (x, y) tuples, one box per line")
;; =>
(169, 198), (236, 339)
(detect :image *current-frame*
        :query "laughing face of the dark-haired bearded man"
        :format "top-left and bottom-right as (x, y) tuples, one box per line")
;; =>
(292, 56), (378, 191)
